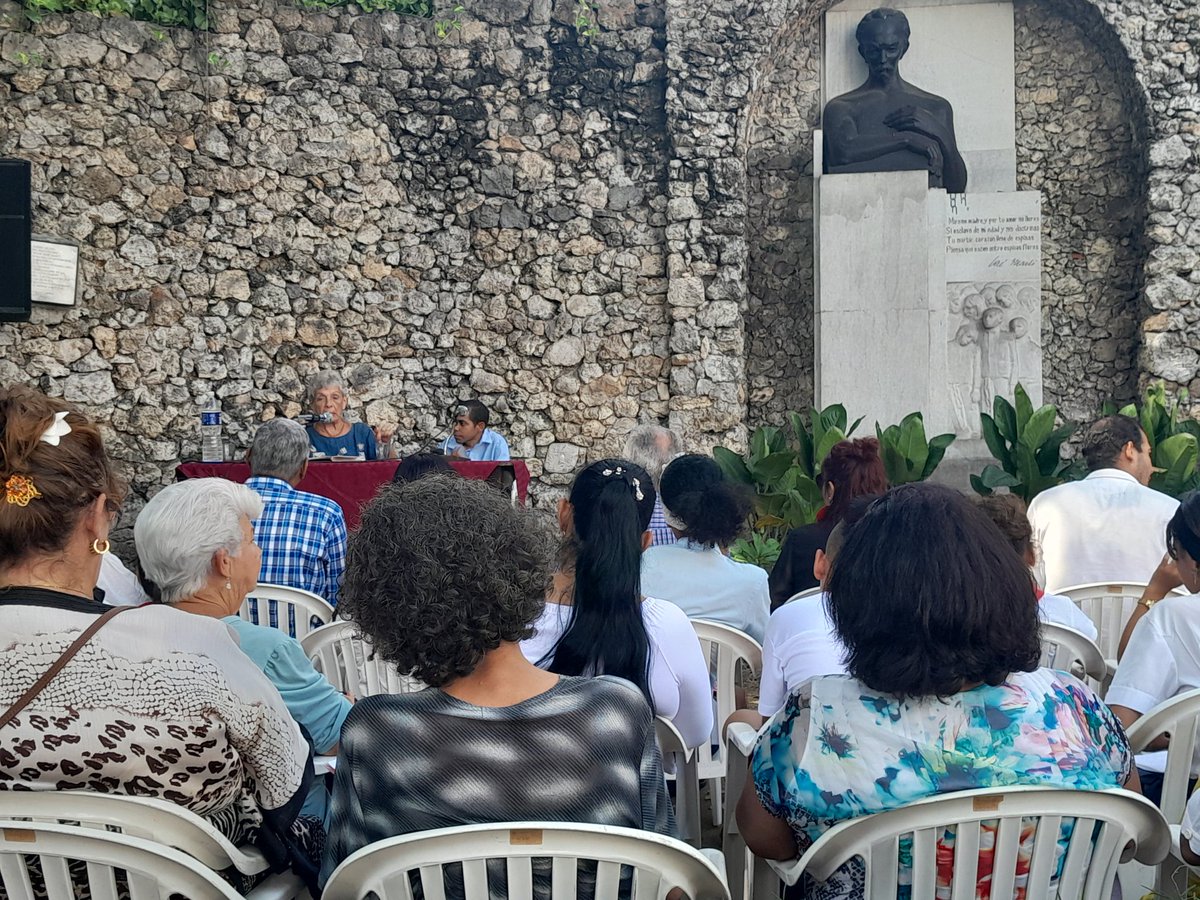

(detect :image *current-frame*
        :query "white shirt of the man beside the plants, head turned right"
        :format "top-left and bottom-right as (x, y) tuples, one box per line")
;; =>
(1028, 469), (1180, 592)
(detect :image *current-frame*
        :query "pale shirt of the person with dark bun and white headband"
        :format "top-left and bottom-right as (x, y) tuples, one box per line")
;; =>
(642, 539), (770, 643)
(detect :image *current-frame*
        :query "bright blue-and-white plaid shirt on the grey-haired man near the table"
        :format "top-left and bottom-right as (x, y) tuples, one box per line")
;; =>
(246, 475), (346, 635)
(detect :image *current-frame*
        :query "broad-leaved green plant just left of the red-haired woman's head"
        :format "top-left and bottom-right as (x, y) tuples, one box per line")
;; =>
(713, 406), (862, 553)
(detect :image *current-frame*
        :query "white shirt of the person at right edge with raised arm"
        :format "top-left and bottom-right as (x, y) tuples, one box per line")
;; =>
(1104, 594), (1200, 773)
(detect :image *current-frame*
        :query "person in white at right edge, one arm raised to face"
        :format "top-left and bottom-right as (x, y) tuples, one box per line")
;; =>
(1104, 491), (1200, 803)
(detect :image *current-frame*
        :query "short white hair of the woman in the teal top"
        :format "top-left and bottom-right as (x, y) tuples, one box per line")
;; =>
(133, 478), (263, 604)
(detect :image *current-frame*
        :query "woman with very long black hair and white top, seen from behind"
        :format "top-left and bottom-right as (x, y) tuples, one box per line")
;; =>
(521, 460), (713, 746)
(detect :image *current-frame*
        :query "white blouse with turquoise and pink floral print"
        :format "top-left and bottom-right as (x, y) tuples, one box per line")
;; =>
(751, 668), (1130, 900)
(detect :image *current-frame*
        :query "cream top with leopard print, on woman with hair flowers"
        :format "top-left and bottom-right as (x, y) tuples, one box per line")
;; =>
(0, 588), (308, 841)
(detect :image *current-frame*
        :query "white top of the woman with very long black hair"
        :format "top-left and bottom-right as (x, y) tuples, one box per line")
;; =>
(521, 596), (713, 746)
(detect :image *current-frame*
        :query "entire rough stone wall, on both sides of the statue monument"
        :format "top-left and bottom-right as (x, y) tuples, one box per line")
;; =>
(0, 0), (1200, 542)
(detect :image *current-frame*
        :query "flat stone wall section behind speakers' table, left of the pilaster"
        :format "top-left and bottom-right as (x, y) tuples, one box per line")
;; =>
(0, 0), (676, 542)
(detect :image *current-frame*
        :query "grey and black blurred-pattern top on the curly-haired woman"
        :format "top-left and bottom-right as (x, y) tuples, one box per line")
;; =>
(320, 676), (676, 884)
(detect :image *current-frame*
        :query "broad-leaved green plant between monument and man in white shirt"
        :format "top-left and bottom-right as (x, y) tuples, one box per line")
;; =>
(971, 384), (1078, 503)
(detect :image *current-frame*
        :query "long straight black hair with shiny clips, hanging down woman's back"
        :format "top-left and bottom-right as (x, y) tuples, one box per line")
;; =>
(546, 460), (654, 706)
